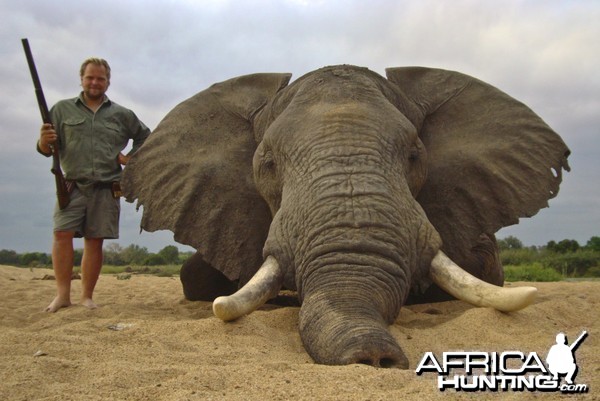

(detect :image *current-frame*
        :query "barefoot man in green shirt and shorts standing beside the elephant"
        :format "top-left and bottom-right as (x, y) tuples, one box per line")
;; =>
(37, 58), (150, 312)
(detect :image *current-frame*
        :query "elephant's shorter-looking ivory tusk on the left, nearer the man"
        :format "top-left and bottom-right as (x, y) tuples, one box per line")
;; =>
(213, 256), (283, 321)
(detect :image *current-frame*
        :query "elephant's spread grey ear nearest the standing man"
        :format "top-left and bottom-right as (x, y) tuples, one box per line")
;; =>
(122, 74), (291, 282)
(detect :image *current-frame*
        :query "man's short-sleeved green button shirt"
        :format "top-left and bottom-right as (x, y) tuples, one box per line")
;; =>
(39, 94), (150, 186)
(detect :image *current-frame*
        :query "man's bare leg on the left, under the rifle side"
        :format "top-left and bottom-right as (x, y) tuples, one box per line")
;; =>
(44, 231), (74, 312)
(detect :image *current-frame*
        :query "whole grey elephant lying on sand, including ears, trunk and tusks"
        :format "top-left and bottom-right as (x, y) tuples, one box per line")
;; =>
(123, 65), (569, 367)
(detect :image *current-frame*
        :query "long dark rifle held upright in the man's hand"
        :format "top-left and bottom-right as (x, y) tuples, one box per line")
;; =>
(21, 39), (74, 209)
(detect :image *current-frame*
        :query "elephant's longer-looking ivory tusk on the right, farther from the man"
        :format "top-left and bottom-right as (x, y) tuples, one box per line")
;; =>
(430, 251), (537, 312)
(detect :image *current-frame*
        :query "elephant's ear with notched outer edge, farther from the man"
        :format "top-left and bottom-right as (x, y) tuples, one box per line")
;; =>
(386, 67), (570, 270)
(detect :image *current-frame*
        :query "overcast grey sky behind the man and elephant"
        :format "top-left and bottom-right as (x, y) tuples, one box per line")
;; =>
(0, 0), (600, 252)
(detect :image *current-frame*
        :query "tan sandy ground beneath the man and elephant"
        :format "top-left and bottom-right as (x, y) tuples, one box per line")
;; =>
(0, 266), (600, 401)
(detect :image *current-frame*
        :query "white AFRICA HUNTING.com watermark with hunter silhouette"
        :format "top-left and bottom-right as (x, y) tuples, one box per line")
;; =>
(415, 331), (589, 394)
